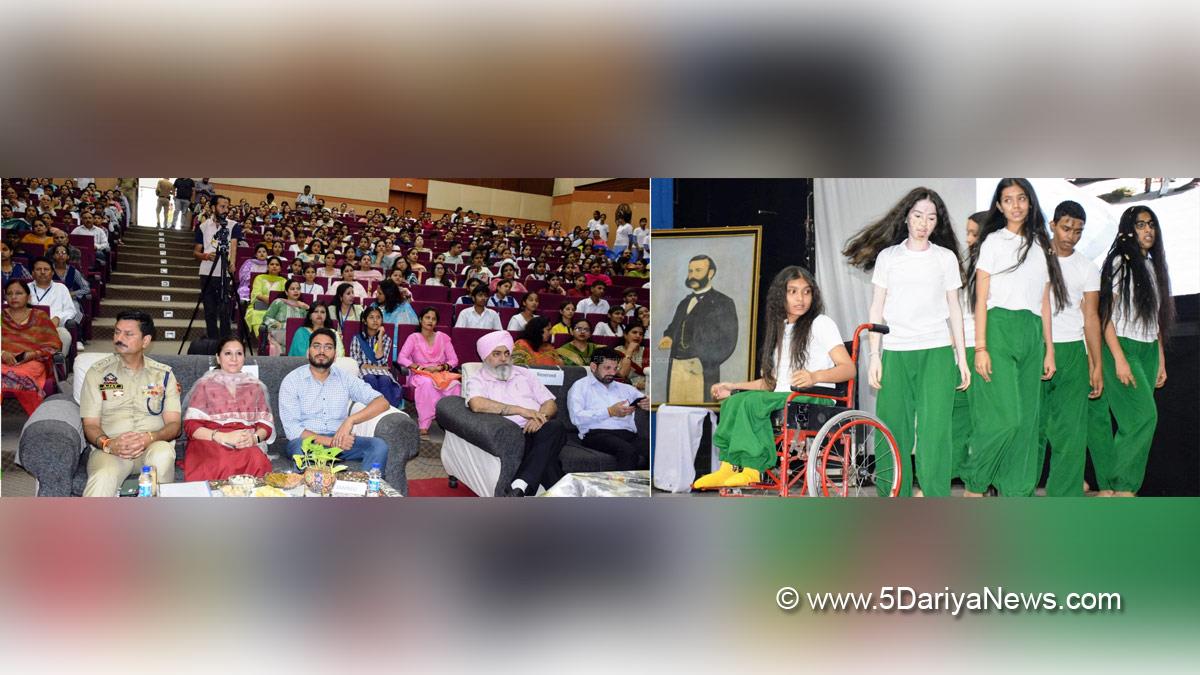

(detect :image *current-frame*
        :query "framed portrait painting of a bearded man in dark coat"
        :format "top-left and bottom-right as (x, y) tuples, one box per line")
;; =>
(647, 226), (762, 408)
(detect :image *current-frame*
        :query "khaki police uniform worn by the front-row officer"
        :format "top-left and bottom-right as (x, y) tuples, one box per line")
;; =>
(79, 354), (181, 497)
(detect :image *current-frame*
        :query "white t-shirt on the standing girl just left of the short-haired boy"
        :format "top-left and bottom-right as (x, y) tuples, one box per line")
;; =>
(976, 229), (1050, 316)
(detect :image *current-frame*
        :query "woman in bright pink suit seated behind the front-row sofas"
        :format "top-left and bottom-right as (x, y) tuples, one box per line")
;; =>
(396, 307), (462, 436)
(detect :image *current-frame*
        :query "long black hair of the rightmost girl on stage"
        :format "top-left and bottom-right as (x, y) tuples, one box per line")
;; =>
(1100, 205), (1175, 336)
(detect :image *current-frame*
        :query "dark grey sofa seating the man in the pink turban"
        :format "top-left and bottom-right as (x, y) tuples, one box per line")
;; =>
(437, 366), (650, 497)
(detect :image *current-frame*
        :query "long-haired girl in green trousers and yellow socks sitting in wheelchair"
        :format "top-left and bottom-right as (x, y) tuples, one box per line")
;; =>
(692, 265), (856, 490)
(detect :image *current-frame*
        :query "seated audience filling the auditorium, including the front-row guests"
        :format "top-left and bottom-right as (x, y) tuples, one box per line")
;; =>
(4, 183), (649, 496)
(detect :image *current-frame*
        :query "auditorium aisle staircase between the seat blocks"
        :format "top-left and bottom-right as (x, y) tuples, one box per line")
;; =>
(84, 226), (211, 354)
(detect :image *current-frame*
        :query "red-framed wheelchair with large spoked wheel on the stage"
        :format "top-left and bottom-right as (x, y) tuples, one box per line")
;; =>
(720, 323), (902, 497)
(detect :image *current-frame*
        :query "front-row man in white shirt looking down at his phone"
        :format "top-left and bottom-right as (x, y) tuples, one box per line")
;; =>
(566, 347), (650, 471)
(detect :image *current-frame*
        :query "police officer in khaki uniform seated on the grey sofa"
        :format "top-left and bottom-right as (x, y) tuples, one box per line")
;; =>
(79, 310), (181, 497)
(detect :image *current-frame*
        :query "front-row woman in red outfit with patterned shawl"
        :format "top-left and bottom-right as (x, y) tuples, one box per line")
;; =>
(184, 338), (275, 480)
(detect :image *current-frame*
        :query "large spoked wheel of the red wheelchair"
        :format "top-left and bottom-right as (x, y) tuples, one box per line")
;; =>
(808, 410), (901, 497)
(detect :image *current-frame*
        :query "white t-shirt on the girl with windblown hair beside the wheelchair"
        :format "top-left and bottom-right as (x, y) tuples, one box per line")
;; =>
(871, 239), (962, 352)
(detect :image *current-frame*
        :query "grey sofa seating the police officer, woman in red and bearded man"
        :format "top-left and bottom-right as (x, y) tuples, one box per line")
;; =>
(19, 354), (419, 497)
